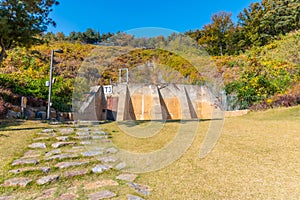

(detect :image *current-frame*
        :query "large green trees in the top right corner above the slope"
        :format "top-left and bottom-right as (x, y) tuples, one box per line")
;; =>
(238, 0), (300, 48)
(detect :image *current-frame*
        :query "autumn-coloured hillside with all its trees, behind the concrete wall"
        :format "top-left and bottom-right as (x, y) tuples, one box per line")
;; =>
(0, 0), (300, 117)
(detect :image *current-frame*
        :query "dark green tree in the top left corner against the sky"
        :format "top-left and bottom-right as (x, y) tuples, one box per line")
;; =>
(0, 0), (59, 63)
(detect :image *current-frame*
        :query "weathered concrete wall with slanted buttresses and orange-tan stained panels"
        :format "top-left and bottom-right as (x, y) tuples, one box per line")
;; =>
(79, 84), (220, 121)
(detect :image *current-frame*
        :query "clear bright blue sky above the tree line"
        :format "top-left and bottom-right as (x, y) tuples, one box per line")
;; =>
(48, 0), (255, 35)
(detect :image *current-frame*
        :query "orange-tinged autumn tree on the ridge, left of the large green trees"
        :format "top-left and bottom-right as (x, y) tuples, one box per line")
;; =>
(198, 12), (234, 55)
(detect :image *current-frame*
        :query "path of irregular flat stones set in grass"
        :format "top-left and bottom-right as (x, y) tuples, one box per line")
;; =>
(0, 126), (151, 200)
